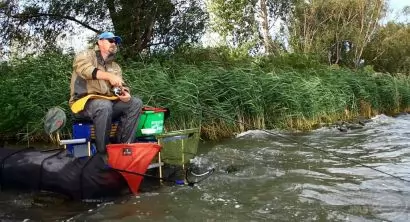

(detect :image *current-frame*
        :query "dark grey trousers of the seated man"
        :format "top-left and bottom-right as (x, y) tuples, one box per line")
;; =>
(79, 97), (143, 153)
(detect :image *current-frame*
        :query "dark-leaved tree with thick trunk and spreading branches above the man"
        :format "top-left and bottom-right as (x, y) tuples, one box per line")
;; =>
(0, 0), (207, 56)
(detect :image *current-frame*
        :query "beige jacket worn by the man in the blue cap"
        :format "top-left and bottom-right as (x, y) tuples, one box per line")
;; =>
(69, 46), (129, 106)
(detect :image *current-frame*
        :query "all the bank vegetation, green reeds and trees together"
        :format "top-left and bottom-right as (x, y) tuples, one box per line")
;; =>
(0, 0), (410, 140)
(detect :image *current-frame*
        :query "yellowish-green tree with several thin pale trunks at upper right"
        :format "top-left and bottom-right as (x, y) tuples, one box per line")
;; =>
(291, 0), (386, 67)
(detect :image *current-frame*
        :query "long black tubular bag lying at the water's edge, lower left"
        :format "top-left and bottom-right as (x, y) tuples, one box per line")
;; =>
(0, 148), (129, 200)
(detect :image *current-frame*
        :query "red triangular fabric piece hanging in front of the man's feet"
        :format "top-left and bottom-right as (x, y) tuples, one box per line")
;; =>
(107, 143), (161, 194)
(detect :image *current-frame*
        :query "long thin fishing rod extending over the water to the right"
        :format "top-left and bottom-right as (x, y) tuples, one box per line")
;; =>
(139, 89), (410, 183)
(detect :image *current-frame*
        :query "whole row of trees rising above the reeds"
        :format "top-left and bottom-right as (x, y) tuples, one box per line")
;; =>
(0, 0), (410, 72)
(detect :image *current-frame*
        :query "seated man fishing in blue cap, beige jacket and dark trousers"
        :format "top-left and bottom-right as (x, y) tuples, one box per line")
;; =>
(69, 32), (143, 154)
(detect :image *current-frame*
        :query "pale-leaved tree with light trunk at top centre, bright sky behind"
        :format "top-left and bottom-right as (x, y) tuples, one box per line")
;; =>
(208, 0), (297, 54)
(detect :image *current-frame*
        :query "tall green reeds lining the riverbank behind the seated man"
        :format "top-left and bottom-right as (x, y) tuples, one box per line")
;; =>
(0, 52), (410, 141)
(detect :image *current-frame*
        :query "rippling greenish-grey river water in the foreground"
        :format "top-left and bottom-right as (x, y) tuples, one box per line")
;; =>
(0, 115), (410, 221)
